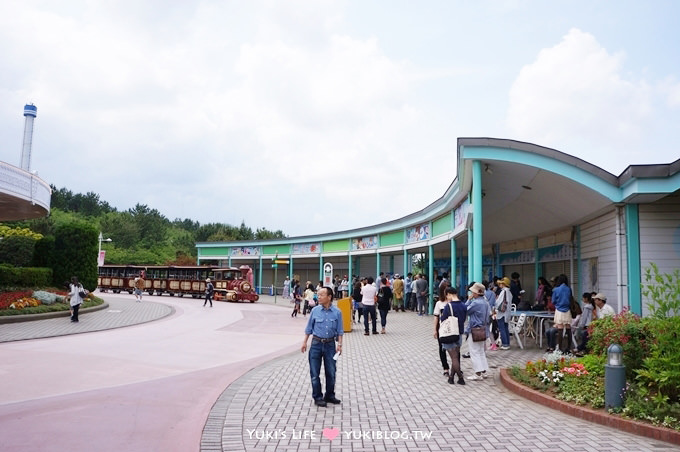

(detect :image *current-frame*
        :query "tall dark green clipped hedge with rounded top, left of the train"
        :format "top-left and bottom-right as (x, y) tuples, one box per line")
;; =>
(54, 223), (98, 290)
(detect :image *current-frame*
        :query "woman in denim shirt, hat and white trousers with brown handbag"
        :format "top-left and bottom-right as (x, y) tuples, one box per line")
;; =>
(467, 282), (491, 381)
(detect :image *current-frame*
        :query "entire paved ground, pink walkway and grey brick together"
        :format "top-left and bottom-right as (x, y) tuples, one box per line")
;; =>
(0, 295), (678, 452)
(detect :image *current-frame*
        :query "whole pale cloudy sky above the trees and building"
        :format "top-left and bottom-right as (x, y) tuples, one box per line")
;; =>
(0, 0), (680, 236)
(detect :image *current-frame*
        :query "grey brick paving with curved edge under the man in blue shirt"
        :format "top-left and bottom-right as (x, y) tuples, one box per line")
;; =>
(201, 299), (678, 452)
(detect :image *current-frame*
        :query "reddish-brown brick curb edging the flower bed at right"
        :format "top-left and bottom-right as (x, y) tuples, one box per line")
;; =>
(500, 369), (680, 445)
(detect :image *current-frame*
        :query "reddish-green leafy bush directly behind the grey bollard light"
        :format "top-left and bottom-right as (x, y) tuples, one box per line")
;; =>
(588, 309), (653, 380)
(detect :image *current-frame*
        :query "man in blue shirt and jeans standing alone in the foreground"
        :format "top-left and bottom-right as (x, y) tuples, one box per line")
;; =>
(300, 287), (344, 407)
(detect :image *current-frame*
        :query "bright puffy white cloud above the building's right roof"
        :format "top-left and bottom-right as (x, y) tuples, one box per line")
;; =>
(507, 29), (653, 167)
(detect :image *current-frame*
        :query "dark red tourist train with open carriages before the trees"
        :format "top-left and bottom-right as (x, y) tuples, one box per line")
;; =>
(97, 265), (260, 303)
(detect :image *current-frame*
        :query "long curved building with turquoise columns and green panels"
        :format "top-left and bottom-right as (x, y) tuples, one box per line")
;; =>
(196, 138), (680, 314)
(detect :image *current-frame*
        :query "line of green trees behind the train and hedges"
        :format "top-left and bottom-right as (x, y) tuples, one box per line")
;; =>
(3, 186), (286, 265)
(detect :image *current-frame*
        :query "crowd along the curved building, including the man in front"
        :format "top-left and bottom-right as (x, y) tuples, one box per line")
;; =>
(284, 272), (614, 406)
